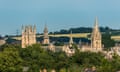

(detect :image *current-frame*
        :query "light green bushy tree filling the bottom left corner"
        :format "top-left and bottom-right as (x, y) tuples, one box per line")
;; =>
(0, 47), (22, 72)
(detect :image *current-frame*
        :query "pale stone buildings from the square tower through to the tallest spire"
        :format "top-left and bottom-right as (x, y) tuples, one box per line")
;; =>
(21, 18), (103, 56)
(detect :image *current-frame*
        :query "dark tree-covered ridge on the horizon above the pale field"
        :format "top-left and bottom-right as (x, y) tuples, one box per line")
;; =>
(49, 27), (120, 35)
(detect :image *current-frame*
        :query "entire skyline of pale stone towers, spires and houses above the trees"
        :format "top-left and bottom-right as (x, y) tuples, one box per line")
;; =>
(0, 18), (116, 58)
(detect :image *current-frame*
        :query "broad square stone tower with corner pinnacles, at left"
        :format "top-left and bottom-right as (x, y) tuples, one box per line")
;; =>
(21, 25), (36, 48)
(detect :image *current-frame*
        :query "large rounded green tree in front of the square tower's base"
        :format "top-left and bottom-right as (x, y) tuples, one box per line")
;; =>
(20, 44), (54, 72)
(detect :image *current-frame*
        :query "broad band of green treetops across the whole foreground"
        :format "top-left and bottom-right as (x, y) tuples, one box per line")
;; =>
(0, 44), (120, 72)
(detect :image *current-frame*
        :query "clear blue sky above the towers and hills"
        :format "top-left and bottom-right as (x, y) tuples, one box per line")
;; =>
(0, 0), (120, 35)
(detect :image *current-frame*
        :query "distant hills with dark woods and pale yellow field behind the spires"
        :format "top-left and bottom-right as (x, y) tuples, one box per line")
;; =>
(6, 27), (120, 43)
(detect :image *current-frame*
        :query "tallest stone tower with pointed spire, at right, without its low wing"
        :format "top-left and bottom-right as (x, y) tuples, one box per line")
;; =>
(91, 17), (102, 51)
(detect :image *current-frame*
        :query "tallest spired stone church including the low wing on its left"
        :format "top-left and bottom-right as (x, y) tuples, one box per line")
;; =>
(81, 17), (102, 52)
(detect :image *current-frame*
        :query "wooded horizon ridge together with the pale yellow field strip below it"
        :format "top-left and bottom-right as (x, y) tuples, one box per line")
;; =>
(6, 27), (120, 41)
